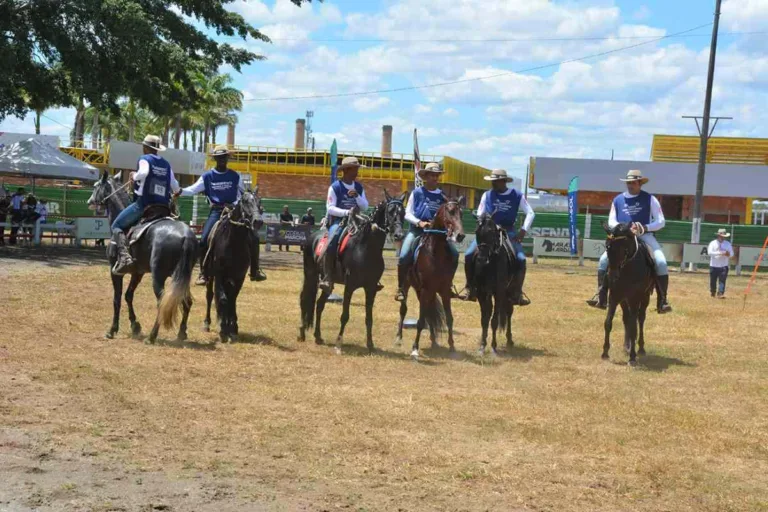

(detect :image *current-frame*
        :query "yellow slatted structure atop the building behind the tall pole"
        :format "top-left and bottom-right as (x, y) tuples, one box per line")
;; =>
(651, 135), (768, 165)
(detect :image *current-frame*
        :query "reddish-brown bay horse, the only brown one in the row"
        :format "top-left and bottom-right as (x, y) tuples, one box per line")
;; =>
(395, 197), (464, 360)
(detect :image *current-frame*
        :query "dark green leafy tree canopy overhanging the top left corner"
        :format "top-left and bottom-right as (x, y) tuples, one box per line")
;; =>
(0, 0), (311, 120)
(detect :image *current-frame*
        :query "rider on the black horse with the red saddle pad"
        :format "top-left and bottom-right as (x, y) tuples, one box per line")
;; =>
(318, 156), (368, 293)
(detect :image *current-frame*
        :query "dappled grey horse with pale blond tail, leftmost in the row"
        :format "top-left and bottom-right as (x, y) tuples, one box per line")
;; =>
(88, 171), (197, 343)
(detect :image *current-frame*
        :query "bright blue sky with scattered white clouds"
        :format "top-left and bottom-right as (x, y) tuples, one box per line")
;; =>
(0, 0), (768, 177)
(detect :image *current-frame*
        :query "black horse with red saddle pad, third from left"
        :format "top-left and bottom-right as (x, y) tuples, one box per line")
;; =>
(298, 190), (405, 354)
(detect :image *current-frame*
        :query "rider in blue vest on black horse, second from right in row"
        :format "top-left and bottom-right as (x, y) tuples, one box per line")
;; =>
(459, 169), (536, 306)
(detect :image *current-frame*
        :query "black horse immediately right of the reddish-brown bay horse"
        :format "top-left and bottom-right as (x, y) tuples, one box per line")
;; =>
(472, 214), (519, 355)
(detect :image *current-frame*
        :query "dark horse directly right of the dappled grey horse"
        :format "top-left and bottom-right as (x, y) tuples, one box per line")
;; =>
(203, 187), (261, 343)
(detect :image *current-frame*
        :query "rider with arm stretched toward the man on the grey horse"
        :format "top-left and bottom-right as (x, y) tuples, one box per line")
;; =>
(178, 146), (267, 285)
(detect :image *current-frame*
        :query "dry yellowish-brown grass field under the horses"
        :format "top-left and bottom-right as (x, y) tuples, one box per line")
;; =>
(0, 248), (768, 512)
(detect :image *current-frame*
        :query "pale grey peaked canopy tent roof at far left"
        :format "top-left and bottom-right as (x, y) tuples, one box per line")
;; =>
(0, 138), (99, 181)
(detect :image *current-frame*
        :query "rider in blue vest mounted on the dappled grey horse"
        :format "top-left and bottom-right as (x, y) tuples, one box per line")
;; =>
(112, 135), (179, 276)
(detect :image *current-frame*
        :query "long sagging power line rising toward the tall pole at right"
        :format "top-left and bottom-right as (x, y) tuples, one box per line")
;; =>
(244, 23), (712, 101)
